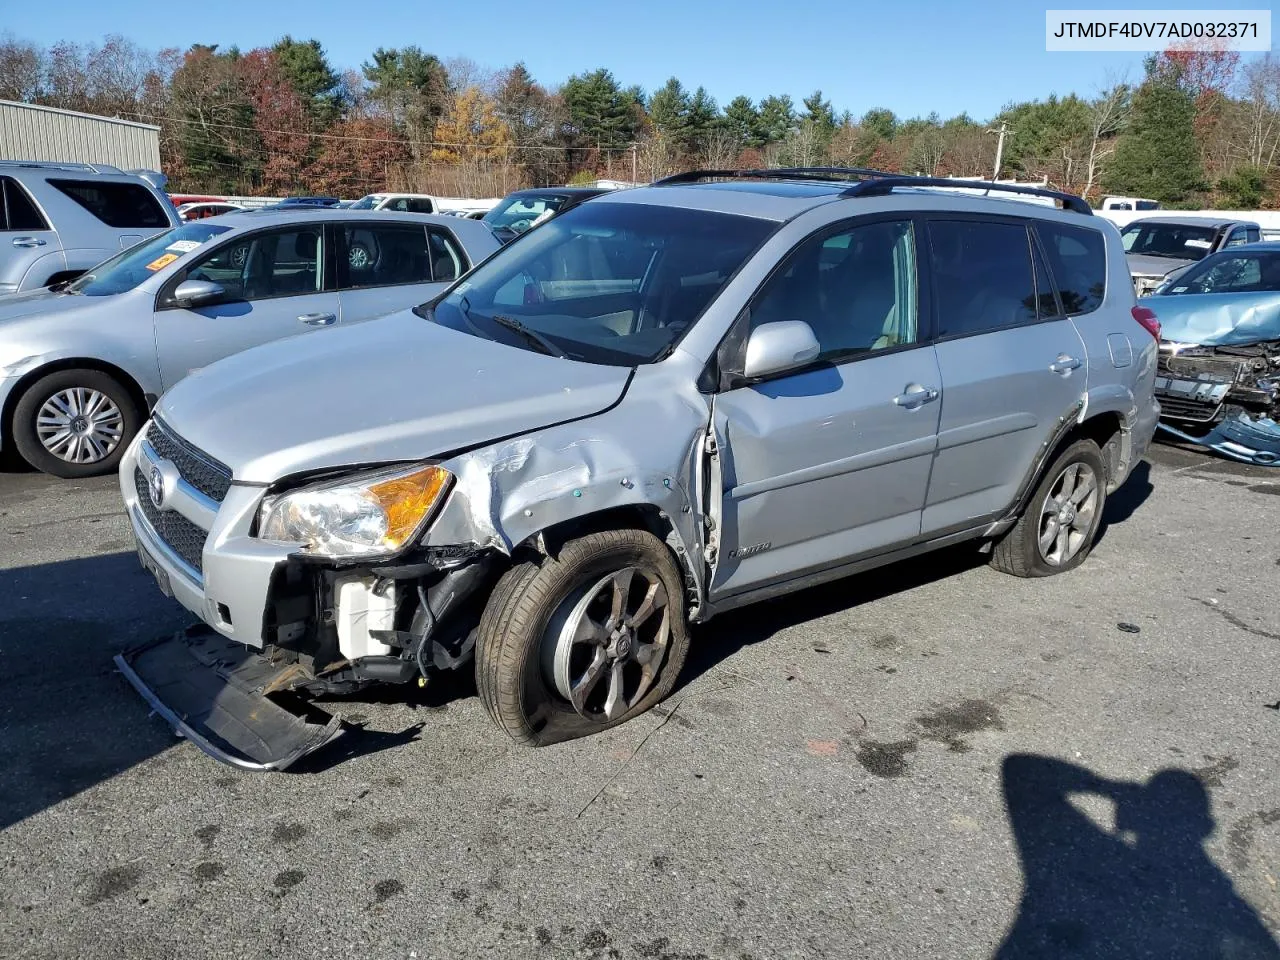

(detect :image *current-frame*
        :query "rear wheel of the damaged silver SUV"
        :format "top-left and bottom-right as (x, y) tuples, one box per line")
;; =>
(991, 440), (1107, 577)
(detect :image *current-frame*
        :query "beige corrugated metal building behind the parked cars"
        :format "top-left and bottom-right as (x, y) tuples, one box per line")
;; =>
(0, 100), (160, 170)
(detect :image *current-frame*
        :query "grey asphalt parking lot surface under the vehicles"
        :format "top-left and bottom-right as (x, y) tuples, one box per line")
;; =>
(0, 445), (1280, 960)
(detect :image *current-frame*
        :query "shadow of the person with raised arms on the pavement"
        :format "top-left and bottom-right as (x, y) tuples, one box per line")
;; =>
(995, 754), (1280, 960)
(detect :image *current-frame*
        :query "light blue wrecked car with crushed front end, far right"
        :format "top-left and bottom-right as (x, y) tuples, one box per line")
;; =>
(1142, 243), (1280, 466)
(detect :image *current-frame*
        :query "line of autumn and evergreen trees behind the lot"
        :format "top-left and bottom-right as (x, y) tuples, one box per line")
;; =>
(0, 36), (1280, 209)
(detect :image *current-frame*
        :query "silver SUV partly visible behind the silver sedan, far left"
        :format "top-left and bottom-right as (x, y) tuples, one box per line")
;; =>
(0, 160), (179, 293)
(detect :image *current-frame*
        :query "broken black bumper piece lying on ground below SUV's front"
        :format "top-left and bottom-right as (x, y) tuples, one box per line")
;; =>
(115, 626), (342, 771)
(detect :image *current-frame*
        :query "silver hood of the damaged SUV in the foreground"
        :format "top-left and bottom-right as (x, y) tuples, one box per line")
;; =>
(156, 311), (631, 484)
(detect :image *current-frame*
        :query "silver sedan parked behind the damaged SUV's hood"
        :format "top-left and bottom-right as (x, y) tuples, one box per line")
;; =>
(0, 210), (499, 477)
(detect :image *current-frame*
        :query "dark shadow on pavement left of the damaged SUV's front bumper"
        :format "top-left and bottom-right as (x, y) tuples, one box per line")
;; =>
(0, 552), (189, 829)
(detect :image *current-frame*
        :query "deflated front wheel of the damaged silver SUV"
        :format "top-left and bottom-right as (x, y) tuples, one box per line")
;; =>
(476, 530), (689, 746)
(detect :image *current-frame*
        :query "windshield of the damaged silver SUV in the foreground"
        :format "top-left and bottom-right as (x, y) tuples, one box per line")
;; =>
(419, 204), (777, 366)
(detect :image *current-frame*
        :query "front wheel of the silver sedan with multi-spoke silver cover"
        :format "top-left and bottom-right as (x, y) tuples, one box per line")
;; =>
(13, 370), (142, 480)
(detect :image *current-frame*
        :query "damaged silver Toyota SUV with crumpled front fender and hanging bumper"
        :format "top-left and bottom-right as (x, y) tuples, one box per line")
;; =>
(118, 169), (1158, 767)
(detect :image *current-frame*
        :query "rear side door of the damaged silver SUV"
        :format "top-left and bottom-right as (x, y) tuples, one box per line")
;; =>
(922, 216), (1088, 536)
